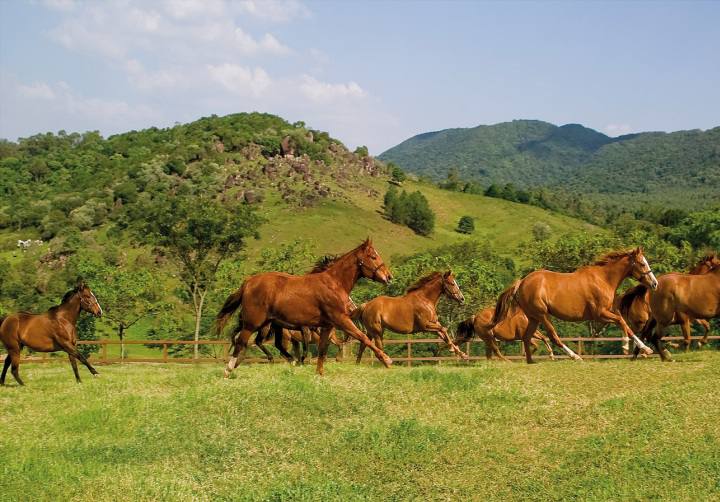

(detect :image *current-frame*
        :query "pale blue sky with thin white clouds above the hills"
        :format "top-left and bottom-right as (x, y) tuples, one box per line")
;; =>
(0, 0), (720, 154)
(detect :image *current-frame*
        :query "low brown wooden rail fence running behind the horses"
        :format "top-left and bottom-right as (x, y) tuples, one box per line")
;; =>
(0, 336), (720, 366)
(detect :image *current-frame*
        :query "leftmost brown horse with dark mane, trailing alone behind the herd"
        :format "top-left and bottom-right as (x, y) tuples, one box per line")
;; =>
(0, 282), (102, 385)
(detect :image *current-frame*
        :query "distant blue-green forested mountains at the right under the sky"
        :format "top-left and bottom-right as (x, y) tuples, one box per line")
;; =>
(379, 120), (720, 208)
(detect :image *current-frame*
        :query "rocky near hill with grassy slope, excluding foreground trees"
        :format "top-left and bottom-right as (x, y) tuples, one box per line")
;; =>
(0, 113), (602, 355)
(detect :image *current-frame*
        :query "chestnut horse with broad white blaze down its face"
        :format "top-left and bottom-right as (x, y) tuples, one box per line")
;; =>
(492, 248), (657, 363)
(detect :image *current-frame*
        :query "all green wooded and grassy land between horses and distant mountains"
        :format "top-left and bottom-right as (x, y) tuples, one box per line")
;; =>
(0, 113), (720, 355)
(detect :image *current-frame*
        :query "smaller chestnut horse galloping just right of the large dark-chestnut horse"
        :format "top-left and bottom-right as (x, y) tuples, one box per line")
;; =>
(352, 270), (468, 363)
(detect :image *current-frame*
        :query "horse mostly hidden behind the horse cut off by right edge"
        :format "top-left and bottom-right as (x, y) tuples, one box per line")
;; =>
(617, 254), (720, 351)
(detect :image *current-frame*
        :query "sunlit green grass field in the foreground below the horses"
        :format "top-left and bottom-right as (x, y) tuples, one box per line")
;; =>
(0, 351), (720, 501)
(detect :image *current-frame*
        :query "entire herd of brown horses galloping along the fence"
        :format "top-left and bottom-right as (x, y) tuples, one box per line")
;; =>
(0, 238), (720, 385)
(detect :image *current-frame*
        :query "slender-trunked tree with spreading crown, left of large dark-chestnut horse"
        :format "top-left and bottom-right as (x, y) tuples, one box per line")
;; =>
(136, 195), (261, 359)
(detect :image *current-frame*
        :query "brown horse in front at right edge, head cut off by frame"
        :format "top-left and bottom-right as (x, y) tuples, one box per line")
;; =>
(635, 255), (720, 361)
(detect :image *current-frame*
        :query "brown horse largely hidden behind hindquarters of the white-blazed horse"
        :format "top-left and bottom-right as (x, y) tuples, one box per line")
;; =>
(455, 307), (555, 362)
